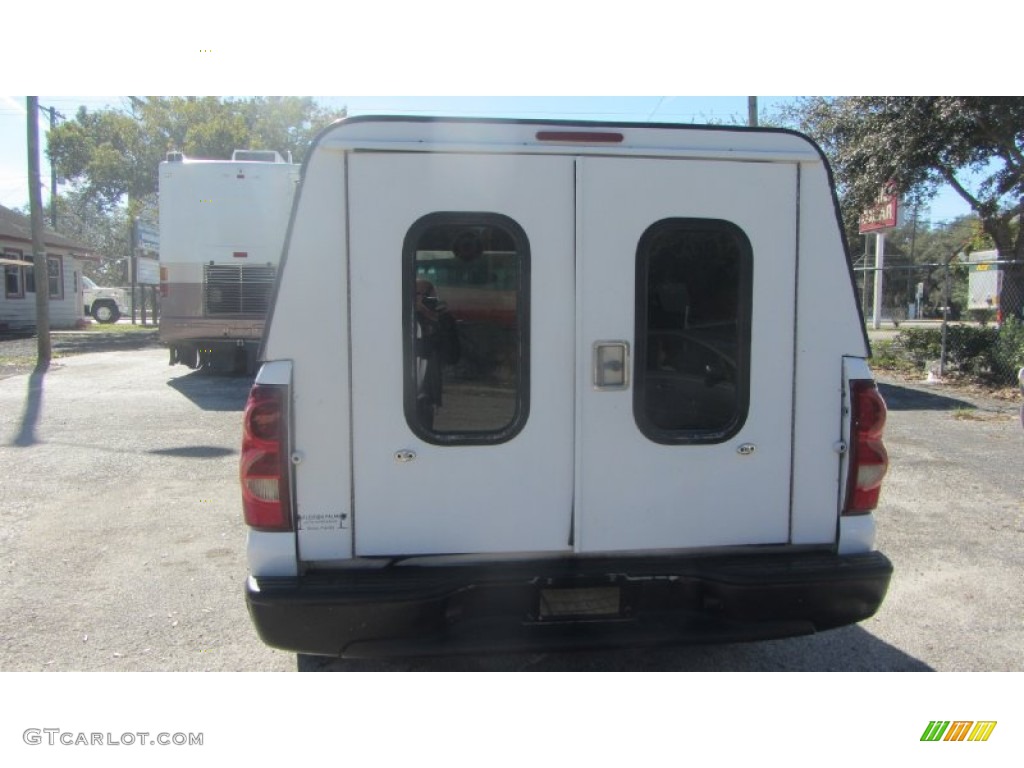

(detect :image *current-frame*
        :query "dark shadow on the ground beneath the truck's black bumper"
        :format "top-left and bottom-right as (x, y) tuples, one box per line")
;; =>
(305, 626), (934, 672)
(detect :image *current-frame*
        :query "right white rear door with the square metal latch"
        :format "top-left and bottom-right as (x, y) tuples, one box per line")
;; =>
(574, 158), (798, 552)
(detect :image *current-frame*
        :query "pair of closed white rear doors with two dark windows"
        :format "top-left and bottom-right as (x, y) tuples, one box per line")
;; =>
(348, 153), (798, 555)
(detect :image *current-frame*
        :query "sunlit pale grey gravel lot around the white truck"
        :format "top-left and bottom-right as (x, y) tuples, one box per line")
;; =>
(0, 331), (1024, 671)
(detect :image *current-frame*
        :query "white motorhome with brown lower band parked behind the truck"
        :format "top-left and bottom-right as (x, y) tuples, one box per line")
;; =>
(160, 150), (299, 372)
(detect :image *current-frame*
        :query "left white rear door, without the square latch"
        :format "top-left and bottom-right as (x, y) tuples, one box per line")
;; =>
(350, 153), (575, 556)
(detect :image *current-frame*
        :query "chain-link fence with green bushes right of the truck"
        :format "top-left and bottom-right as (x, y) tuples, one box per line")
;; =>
(854, 259), (1024, 386)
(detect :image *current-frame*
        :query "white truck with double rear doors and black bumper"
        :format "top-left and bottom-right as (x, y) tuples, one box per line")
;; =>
(241, 118), (892, 659)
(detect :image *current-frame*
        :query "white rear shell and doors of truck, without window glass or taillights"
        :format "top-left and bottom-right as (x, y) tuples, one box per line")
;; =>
(258, 118), (873, 575)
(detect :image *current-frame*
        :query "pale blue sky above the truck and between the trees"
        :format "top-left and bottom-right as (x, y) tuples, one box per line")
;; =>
(0, 95), (970, 222)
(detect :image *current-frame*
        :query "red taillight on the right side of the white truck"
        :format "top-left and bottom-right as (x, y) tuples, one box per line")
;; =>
(843, 379), (889, 515)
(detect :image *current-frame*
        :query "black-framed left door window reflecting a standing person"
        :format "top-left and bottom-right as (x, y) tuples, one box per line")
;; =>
(402, 213), (529, 444)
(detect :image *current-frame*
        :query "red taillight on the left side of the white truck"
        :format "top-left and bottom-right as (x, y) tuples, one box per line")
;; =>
(240, 384), (292, 530)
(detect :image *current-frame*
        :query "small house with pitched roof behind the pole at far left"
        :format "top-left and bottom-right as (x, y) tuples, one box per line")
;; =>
(0, 206), (95, 332)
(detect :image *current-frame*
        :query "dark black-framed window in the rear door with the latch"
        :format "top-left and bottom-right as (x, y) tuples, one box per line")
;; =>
(633, 218), (753, 443)
